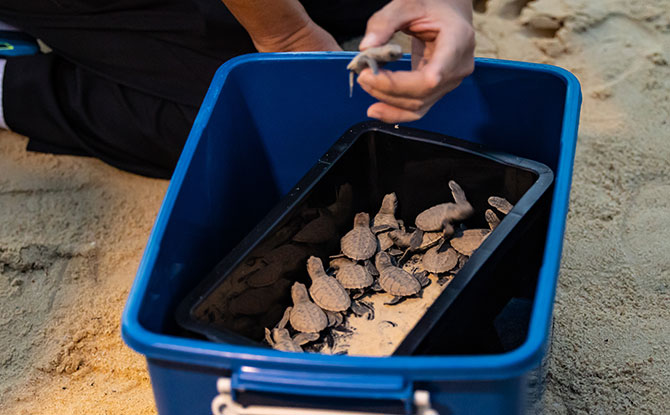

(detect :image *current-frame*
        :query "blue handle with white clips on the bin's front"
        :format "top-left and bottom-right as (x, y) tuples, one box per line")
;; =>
(212, 366), (438, 415)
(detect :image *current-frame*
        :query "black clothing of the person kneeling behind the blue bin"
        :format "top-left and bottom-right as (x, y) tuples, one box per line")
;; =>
(0, 0), (385, 177)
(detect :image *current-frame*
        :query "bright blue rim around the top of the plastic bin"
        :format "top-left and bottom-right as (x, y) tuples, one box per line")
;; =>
(121, 52), (581, 380)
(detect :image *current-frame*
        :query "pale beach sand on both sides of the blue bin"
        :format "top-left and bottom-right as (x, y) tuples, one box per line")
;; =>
(0, 0), (670, 415)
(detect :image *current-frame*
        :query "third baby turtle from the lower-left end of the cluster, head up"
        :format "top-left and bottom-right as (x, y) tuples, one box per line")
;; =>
(307, 256), (351, 312)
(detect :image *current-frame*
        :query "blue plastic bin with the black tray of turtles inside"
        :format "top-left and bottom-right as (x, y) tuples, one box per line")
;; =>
(122, 53), (581, 415)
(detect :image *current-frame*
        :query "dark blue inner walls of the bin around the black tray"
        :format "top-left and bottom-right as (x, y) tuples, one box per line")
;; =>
(138, 54), (570, 360)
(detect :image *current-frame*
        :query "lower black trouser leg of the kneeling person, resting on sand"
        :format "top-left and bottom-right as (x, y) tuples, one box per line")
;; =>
(2, 54), (197, 178)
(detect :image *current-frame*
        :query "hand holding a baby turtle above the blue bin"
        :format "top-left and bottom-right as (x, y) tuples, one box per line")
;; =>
(358, 0), (475, 123)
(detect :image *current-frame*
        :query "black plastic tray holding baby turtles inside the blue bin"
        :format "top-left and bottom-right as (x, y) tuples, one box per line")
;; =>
(176, 122), (553, 355)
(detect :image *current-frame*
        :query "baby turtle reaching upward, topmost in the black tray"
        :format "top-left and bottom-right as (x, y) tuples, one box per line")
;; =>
(415, 180), (473, 233)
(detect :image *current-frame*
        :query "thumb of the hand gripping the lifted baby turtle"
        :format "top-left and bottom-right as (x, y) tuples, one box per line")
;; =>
(358, 0), (417, 50)
